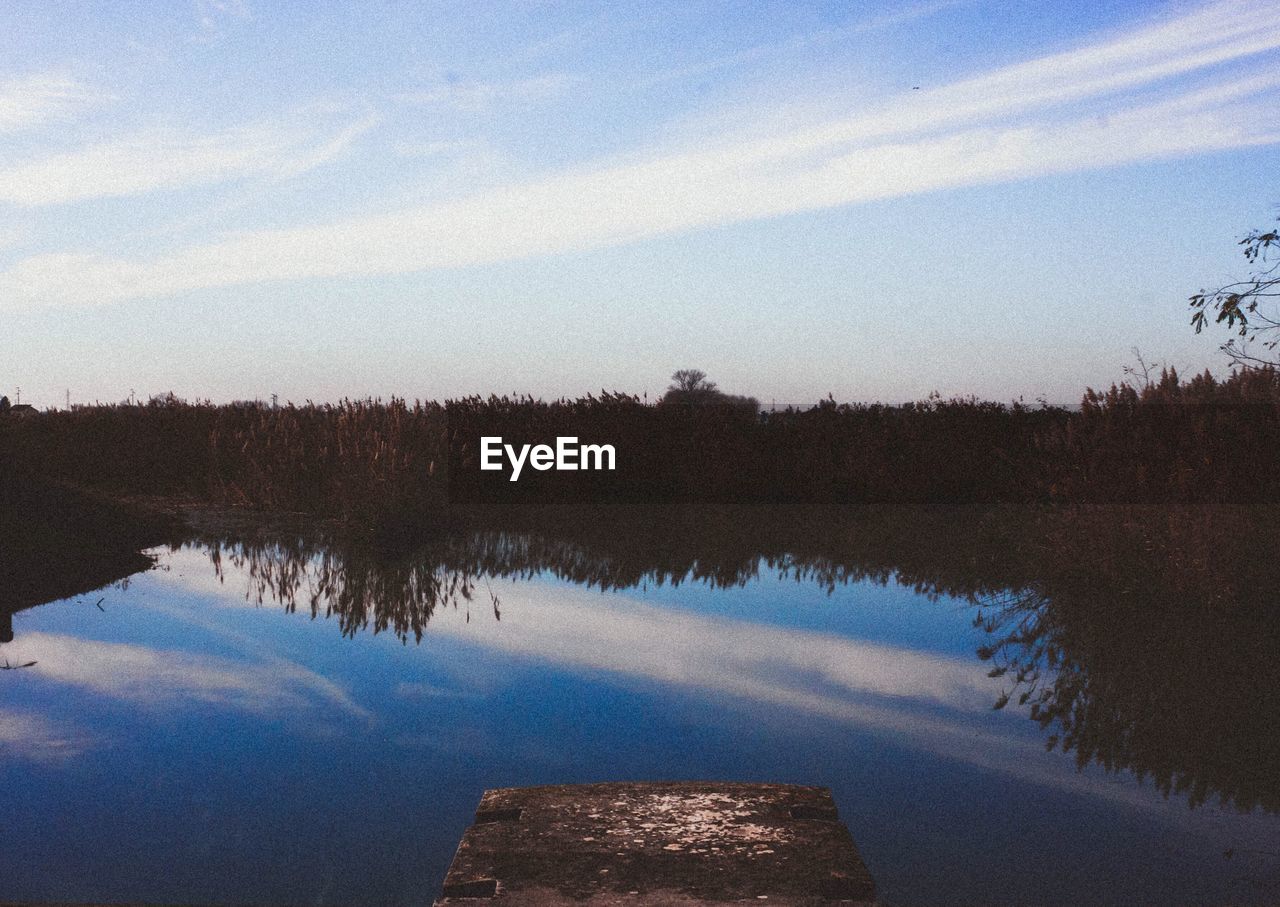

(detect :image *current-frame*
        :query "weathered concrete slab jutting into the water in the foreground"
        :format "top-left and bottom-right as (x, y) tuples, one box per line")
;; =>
(436, 782), (876, 907)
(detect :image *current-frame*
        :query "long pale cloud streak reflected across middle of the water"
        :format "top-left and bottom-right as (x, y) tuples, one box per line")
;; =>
(431, 583), (1198, 808)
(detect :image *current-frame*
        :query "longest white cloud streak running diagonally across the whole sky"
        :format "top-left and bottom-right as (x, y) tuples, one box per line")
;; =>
(0, 0), (1280, 310)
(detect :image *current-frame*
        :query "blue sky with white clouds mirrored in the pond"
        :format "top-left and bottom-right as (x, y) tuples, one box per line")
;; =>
(0, 542), (1280, 903)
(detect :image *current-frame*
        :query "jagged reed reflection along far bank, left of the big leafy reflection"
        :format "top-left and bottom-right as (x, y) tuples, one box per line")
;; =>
(193, 508), (1029, 641)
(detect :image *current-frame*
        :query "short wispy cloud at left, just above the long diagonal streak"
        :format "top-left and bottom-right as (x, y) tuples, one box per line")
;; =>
(0, 110), (378, 207)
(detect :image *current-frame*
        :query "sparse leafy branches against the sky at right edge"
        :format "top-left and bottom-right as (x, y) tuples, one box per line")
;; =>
(1190, 213), (1280, 367)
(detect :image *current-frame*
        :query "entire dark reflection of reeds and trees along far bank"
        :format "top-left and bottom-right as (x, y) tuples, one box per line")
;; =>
(192, 508), (1280, 811)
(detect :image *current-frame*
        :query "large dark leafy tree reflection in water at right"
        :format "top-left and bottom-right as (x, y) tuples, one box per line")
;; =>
(975, 510), (1280, 812)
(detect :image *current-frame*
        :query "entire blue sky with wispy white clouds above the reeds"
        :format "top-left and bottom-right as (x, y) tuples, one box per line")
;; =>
(0, 0), (1280, 407)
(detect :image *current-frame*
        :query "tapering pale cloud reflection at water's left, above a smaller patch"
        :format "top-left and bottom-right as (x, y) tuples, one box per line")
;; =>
(26, 633), (367, 716)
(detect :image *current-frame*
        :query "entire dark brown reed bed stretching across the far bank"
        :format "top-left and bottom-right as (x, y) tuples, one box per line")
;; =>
(0, 368), (1280, 526)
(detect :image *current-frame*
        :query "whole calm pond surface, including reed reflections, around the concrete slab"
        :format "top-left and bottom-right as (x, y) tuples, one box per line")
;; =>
(0, 506), (1280, 904)
